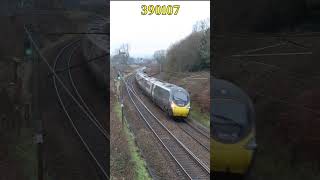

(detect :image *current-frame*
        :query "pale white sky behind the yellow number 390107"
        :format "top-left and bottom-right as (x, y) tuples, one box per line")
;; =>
(110, 1), (210, 58)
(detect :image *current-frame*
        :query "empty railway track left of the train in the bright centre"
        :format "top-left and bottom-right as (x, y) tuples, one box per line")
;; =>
(124, 74), (210, 179)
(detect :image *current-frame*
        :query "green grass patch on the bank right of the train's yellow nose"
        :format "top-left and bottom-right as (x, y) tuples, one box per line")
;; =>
(189, 103), (210, 128)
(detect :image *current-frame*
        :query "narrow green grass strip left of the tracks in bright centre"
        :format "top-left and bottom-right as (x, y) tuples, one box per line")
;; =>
(114, 102), (151, 180)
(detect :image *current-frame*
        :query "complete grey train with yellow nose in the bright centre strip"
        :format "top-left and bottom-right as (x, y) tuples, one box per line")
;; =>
(136, 67), (190, 118)
